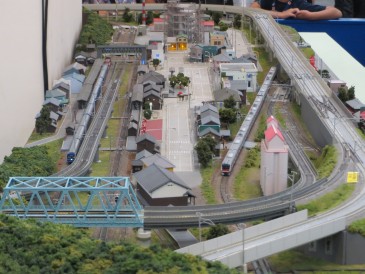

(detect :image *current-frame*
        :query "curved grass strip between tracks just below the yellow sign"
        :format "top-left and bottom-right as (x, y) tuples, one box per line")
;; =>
(297, 184), (355, 216)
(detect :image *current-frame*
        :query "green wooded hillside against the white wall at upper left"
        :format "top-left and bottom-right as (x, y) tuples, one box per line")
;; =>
(79, 9), (113, 50)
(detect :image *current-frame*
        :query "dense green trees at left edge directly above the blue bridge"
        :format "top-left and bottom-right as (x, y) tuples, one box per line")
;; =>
(0, 146), (56, 191)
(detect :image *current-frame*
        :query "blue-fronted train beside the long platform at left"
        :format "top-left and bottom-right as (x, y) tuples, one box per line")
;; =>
(66, 58), (111, 165)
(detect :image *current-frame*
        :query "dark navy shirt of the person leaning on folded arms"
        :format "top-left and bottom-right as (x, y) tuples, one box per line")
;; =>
(257, 0), (326, 12)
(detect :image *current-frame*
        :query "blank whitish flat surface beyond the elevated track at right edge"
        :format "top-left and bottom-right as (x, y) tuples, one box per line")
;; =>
(299, 32), (365, 103)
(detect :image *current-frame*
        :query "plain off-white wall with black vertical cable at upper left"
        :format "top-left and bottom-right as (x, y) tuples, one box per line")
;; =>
(0, 0), (82, 163)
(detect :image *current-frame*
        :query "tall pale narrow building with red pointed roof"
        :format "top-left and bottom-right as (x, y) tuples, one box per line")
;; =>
(260, 116), (289, 196)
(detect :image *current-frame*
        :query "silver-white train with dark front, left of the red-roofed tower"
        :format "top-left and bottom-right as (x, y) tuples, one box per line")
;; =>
(221, 67), (277, 176)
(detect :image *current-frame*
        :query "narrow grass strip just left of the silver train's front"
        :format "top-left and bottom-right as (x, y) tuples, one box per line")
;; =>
(200, 161), (220, 205)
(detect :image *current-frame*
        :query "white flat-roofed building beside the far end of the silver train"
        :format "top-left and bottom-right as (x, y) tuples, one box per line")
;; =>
(219, 63), (258, 92)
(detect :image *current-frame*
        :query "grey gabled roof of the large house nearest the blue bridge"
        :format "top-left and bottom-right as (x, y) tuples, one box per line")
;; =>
(133, 164), (190, 193)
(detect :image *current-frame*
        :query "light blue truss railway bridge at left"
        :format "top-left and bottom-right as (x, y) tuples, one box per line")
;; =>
(0, 177), (143, 227)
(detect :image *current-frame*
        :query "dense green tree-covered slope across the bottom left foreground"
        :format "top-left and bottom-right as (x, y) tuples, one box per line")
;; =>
(0, 215), (237, 274)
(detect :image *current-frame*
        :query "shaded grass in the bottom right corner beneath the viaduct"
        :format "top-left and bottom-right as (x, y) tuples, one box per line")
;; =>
(269, 250), (364, 274)
